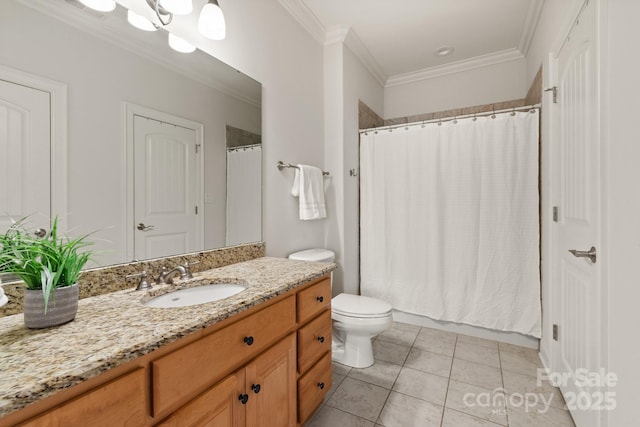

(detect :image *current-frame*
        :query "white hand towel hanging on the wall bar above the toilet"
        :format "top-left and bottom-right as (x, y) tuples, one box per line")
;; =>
(291, 165), (327, 221)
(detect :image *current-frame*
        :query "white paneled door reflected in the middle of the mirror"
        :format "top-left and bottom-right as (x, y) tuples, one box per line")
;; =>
(133, 115), (203, 259)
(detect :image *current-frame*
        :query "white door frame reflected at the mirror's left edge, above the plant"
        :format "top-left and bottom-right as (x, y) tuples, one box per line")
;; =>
(0, 65), (68, 231)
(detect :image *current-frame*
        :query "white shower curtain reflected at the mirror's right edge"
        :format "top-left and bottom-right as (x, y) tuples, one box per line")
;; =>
(226, 146), (262, 246)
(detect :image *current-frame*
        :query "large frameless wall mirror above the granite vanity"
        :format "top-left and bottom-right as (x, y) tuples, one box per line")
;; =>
(0, 0), (262, 265)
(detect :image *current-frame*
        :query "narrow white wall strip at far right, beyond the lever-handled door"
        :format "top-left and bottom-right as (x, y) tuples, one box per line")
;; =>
(601, 0), (640, 427)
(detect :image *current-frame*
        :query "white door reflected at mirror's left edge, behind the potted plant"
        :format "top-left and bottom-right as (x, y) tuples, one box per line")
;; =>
(0, 80), (51, 232)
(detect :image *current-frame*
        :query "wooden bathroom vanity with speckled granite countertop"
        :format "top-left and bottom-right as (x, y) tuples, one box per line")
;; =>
(0, 258), (335, 427)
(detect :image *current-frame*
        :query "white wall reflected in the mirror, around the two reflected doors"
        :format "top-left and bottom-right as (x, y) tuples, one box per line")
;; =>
(0, 1), (261, 265)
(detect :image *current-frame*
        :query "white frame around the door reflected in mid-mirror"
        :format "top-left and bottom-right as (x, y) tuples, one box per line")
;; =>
(123, 102), (205, 261)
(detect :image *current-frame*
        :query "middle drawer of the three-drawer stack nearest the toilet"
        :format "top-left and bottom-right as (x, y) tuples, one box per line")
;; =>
(298, 310), (331, 373)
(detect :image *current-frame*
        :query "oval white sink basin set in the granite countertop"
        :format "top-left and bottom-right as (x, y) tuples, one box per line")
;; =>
(143, 283), (246, 308)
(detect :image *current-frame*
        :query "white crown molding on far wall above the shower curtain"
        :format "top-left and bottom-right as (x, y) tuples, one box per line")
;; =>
(385, 48), (524, 87)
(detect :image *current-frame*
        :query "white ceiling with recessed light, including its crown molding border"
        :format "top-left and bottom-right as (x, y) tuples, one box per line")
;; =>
(280, 0), (544, 86)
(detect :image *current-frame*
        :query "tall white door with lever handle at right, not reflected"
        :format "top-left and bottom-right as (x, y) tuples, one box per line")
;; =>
(550, 2), (610, 427)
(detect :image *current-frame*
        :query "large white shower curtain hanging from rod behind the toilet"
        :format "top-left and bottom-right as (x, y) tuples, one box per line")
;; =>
(360, 110), (541, 337)
